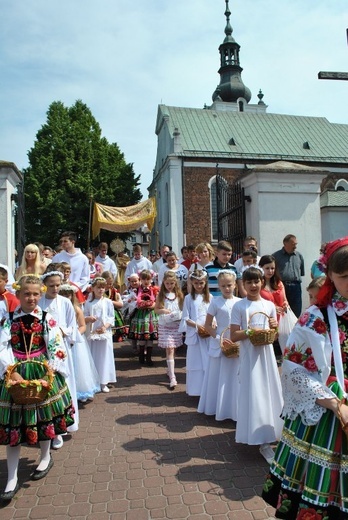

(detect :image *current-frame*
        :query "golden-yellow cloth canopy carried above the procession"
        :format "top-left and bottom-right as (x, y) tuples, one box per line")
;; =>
(92, 197), (157, 238)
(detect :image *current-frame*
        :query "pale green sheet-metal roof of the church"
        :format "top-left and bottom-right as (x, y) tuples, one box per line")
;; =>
(157, 105), (348, 163)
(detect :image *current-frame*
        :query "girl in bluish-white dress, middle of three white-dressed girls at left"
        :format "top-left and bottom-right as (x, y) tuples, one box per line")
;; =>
(59, 284), (100, 403)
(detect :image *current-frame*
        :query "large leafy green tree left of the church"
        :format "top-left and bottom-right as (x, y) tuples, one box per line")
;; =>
(23, 100), (141, 247)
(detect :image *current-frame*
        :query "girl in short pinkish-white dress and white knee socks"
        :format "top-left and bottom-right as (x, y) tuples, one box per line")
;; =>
(155, 271), (184, 389)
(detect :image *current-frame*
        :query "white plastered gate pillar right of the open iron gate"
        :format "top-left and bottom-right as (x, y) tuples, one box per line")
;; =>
(242, 171), (325, 308)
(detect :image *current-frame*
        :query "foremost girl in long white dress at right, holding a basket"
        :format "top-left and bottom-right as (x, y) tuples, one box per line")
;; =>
(231, 267), (283, 463)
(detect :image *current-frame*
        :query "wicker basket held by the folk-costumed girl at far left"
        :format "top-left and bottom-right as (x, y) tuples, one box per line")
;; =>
(5, 359), (54, 404)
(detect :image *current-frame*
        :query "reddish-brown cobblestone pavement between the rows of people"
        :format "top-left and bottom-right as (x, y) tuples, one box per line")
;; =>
(0, 343), (274, 520)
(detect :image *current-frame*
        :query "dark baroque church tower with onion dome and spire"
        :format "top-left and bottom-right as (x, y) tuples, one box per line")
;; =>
(212, 0), (251, 103)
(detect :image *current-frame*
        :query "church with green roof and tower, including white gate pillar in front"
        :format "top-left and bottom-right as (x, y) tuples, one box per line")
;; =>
(149, 0), (348, 261)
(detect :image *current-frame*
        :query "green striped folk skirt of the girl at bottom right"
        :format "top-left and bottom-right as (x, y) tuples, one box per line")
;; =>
(262, 382), (348, 520)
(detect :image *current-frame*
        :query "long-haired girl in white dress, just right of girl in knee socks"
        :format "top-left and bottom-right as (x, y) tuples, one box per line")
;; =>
(179, 269), (213, 396)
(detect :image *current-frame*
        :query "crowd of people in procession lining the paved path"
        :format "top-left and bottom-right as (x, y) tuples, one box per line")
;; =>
(0, 232), (348, 520)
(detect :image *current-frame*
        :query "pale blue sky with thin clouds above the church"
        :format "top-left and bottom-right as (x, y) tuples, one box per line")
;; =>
(0, 0), (348, 198)
